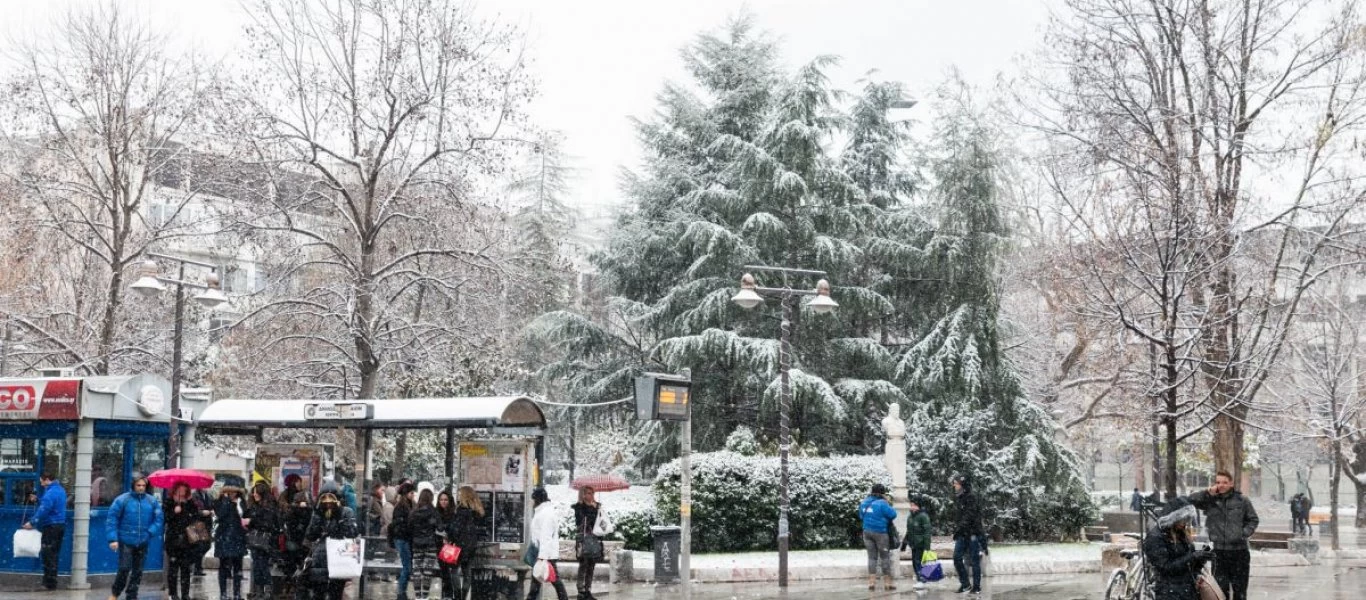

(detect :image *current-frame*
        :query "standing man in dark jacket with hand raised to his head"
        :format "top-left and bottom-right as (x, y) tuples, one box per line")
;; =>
(1188, 472), (1259, 600)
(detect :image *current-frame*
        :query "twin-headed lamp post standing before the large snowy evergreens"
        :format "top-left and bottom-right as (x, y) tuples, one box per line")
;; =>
(731, 265), (839, 588)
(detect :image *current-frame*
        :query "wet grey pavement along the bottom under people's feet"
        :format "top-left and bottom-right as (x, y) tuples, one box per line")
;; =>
(3, 560), (1366, 600)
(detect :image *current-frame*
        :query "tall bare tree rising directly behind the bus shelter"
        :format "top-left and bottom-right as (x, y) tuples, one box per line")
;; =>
(229, 0), (530, 461)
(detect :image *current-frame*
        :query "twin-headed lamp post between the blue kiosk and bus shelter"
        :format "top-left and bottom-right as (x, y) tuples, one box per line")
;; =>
(131, 251), (228, 469)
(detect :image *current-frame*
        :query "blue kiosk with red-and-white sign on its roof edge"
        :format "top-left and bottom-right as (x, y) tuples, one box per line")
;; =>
(0, 374), (206, 589)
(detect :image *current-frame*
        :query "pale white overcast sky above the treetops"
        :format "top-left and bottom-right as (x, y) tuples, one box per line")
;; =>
(0, 0), (1049, 244)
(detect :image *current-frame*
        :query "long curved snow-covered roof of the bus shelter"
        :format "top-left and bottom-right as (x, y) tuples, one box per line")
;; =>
(194, 396), (545, 432)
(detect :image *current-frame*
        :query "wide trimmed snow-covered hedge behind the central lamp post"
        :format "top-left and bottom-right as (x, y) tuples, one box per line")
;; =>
(654, 451), (891, 552)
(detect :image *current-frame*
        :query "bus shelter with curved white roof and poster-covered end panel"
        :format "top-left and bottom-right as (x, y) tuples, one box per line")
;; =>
(195, 396), (546, 598)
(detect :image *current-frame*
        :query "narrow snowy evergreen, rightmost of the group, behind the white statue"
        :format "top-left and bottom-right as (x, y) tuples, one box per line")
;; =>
(897, 83), (1094, 538)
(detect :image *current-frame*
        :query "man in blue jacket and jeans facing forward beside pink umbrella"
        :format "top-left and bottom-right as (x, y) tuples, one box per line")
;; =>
(105, 477), (161, 600)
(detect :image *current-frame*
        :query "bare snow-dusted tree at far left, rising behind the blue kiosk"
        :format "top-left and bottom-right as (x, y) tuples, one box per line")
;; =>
(0, 3), (214, 373)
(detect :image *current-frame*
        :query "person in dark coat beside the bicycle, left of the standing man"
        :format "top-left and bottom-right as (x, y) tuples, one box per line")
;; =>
(1143, 499), (1214, 600)
